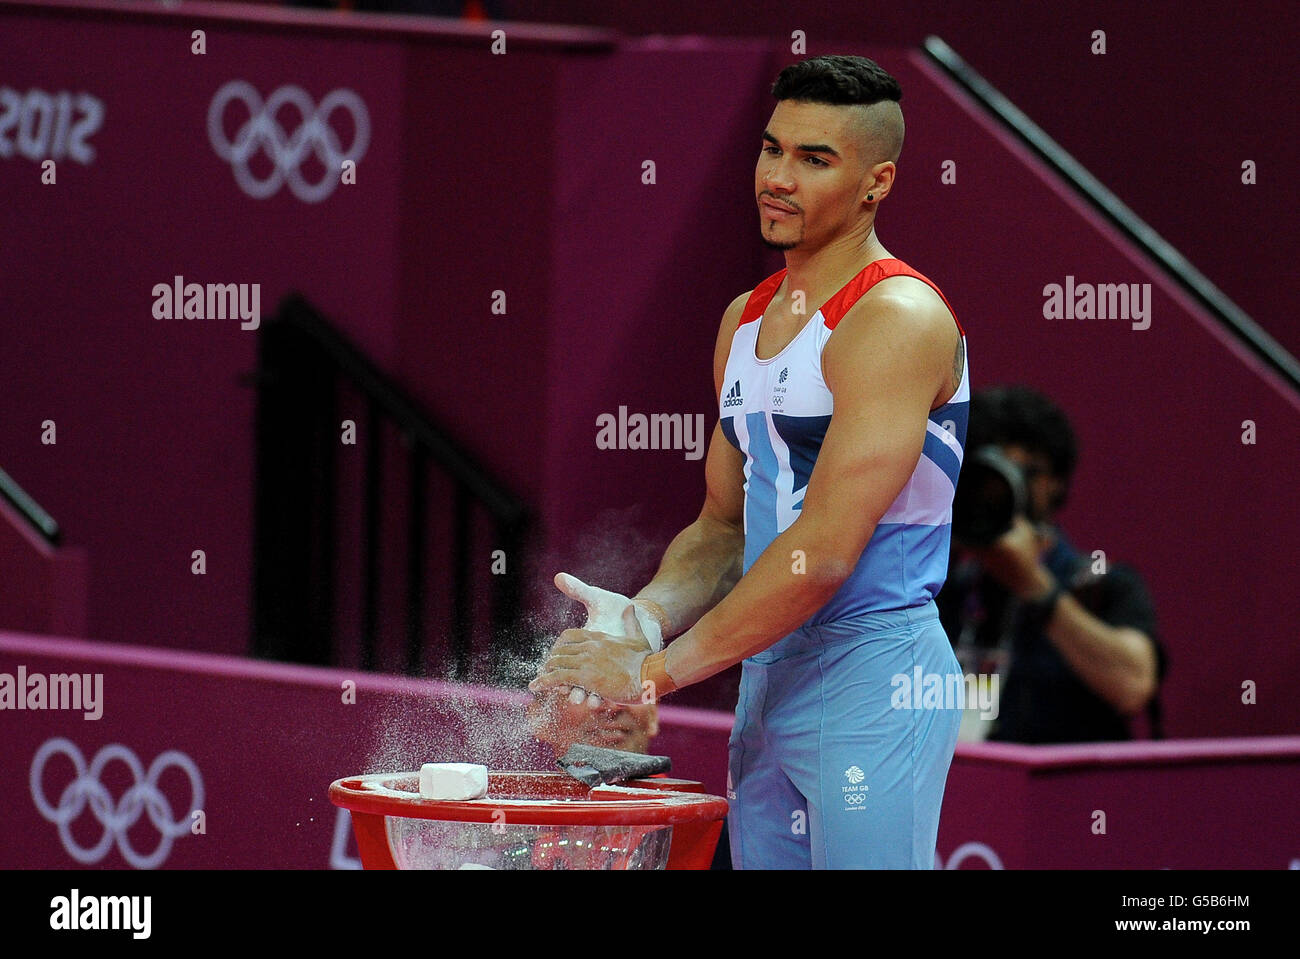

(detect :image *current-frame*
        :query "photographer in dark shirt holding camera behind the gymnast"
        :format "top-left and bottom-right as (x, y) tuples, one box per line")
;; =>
(936, 386), (1165, 743)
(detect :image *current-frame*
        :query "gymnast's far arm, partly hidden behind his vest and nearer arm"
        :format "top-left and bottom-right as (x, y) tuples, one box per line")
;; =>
(633, 292), (749, 639)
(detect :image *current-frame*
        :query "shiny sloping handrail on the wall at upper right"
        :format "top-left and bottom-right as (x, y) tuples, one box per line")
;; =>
(924, 36), (1300, 391)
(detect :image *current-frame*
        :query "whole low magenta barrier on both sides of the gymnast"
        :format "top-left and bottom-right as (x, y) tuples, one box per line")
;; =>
(0, 633), (1300, 869)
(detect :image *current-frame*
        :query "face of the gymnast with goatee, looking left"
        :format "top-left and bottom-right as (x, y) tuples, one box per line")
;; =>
(754, 100), (878, 249)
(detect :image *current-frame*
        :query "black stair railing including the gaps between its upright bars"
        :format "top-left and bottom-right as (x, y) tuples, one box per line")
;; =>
(252, 295), (528, 681)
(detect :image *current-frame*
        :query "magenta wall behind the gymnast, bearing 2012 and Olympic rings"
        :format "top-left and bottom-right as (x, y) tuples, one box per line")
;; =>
(0, 4), (1300, 735)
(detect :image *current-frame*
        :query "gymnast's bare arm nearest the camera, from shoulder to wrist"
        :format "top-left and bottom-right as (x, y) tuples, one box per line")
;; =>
(664, 281), (958, 686)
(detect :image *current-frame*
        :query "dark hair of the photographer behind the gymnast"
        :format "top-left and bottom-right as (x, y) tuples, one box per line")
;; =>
(966, 386), (1079, 509)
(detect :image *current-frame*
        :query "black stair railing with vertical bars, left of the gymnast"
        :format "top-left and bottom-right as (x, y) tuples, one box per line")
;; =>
(252, 294), (529, 680)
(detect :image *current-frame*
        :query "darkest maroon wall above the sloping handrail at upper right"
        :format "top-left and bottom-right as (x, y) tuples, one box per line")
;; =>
(506, 0), (1300, 356)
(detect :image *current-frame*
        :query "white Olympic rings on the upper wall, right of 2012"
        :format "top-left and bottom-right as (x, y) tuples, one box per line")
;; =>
(208, 81), (371, 203)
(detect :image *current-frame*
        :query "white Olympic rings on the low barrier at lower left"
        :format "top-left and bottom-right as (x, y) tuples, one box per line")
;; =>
(31, 738), (203, 869)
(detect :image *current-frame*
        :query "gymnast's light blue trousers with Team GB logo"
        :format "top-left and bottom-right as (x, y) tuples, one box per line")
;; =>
(727, 602), (962, 869)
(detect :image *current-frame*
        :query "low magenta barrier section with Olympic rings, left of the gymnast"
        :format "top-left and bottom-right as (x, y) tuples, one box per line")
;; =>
(0, 633), (731, 869)
